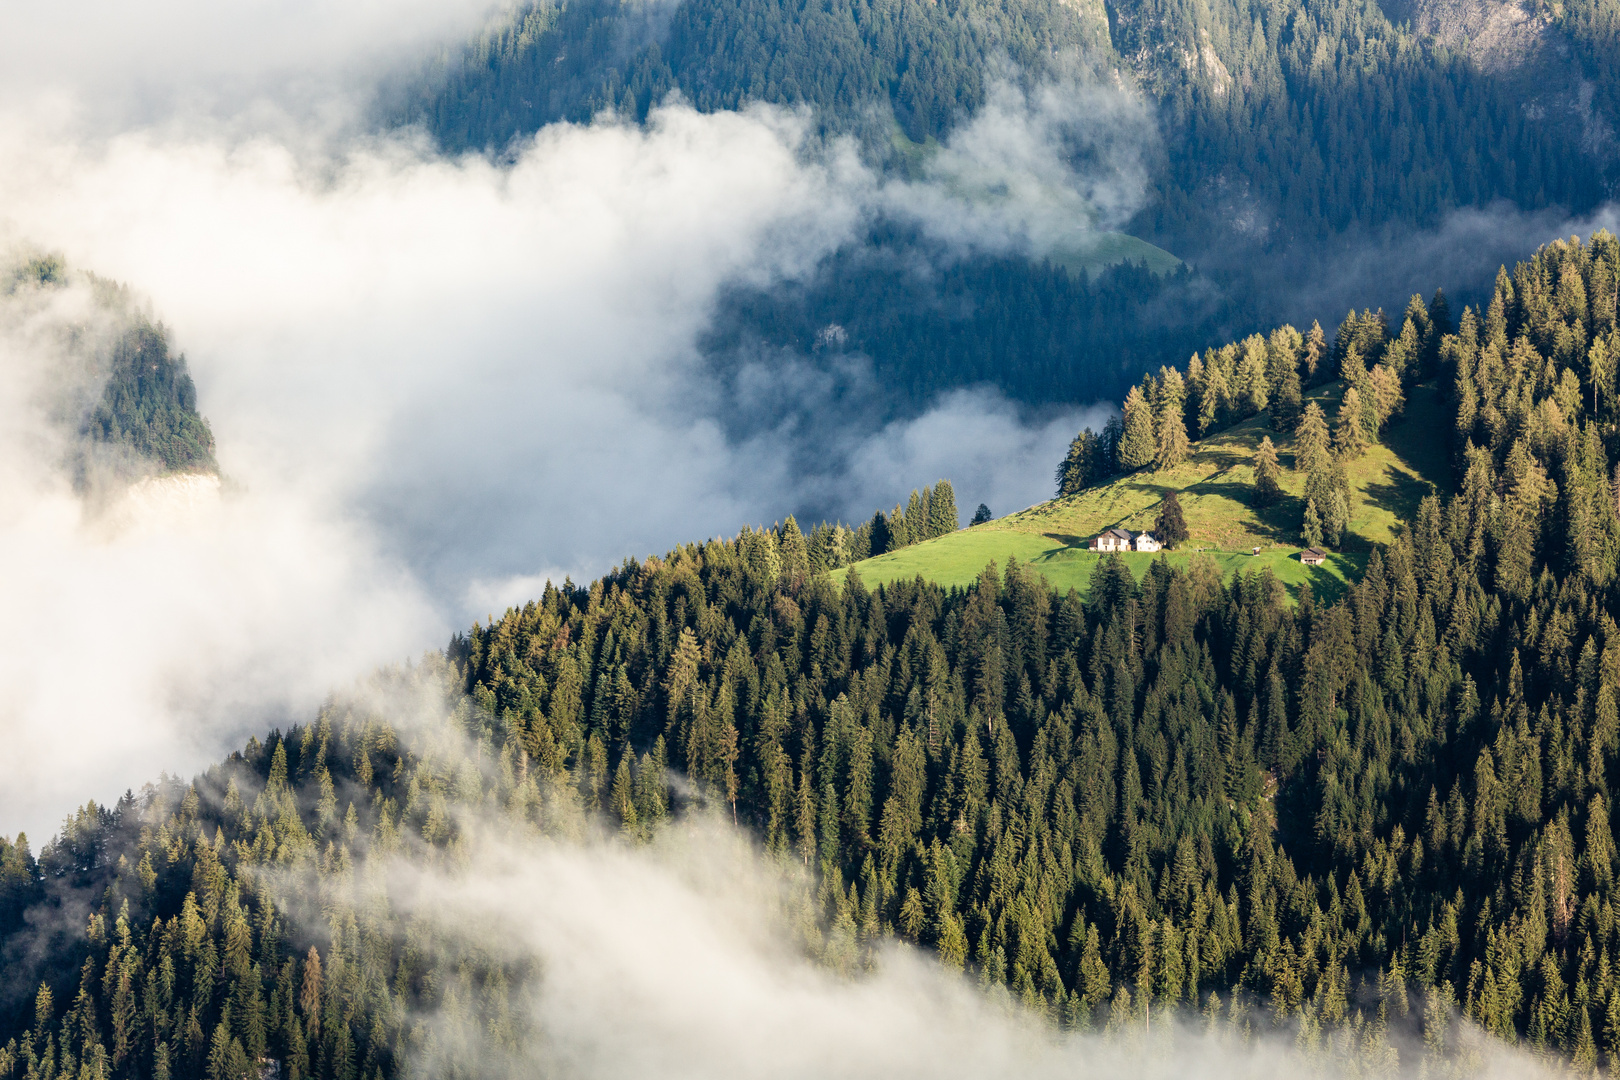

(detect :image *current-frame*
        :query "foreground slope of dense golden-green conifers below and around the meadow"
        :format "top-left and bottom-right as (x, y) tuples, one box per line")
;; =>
(0, 235), (1620, 1080)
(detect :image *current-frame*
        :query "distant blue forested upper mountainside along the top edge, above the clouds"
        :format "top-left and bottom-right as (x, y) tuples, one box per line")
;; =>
(397, 0), (1620, 247)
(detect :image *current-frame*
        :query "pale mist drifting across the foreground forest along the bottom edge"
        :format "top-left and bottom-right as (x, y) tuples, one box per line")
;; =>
(308, 799), (1554, 1080)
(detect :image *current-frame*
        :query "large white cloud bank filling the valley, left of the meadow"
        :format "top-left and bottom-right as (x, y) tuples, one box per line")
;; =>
(0, 46), (1127, 842)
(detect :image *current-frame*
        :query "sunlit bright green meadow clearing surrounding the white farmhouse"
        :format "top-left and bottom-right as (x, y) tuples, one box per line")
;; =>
(855, 382), (1452, 599)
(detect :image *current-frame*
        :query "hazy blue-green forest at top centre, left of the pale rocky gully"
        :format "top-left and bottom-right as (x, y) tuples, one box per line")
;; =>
(400, 0), (1106, 151)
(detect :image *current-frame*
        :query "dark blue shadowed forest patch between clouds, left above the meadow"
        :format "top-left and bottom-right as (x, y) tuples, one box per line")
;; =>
(703, 228), (1236, 403)
